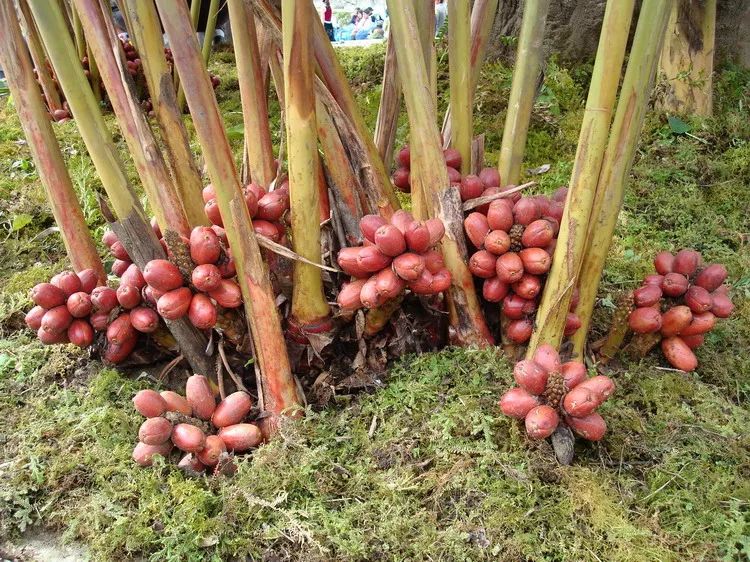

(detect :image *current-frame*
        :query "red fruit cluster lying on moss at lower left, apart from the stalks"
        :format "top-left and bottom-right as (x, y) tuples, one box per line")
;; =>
(133, 375), (263, 472)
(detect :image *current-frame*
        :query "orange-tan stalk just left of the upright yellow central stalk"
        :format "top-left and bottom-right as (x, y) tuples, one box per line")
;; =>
(229, 0), (276, 188)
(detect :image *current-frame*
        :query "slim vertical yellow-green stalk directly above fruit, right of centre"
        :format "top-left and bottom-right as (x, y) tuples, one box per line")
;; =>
(448, 0), (474, 175)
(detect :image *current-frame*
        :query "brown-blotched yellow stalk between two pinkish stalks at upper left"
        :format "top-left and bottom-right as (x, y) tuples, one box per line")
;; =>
(123, 0), (208, 227)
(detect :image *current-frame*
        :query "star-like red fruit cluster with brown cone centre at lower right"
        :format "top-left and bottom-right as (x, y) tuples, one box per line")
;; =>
(500, 344), (615, 441)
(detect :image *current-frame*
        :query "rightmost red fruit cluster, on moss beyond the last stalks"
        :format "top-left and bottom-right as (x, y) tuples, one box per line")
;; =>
(628, 250), (734, 371)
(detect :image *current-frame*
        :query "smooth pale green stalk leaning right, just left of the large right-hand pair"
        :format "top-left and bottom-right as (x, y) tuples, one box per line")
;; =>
(498, 0), (550, 185)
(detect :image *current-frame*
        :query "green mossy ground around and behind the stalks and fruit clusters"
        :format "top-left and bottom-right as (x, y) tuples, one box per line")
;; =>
(0, 47), (750, 561)
